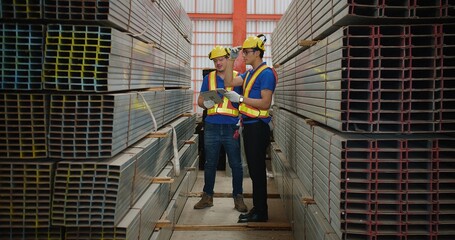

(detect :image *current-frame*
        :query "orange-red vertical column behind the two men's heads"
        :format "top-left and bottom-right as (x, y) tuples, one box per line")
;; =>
(232, 0), (247, 73)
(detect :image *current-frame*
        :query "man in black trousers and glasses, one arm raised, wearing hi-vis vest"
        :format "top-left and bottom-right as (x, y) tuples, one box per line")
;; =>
(224, 34), (277, 222)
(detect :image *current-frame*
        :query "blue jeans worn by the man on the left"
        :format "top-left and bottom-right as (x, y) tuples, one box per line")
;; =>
(204, 122), (243, 196)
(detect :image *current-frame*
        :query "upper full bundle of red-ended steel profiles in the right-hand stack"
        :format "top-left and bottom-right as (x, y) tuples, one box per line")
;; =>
(277, 24), (455, 133)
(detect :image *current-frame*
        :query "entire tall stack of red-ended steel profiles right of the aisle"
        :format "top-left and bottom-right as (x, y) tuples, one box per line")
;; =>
(272, 0), (455, 240)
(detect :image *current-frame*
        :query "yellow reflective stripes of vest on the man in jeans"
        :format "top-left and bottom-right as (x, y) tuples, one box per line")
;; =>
(207, 71), (239, 117)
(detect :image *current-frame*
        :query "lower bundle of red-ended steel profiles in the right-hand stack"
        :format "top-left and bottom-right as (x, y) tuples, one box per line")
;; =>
(274, 109), (455, 239)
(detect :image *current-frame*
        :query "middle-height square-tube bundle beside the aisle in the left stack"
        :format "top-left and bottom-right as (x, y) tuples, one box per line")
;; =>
(49, 91), (173, 159)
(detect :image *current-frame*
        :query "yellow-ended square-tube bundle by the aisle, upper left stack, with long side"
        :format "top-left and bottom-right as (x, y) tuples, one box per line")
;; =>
(43, 25), (175, 92)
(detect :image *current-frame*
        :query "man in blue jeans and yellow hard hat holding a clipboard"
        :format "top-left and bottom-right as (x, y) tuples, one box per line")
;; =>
(194, 46), (248, 212)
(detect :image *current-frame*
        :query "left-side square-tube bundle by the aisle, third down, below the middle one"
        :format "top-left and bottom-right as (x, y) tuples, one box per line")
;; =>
(52, 115), (196, 227)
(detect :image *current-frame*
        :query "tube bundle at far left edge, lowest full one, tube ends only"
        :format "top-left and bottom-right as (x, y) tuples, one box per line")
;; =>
(0, 160), (55, 227)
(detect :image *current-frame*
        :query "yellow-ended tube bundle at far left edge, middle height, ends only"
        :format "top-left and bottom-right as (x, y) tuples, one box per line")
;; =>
(0, 93), (48, 159)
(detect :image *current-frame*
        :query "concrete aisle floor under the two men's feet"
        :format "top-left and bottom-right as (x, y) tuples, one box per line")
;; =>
(171, 170), (293, 240)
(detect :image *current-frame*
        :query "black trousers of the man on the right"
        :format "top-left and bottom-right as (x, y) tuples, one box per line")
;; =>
(243, 121), (270, 214)
